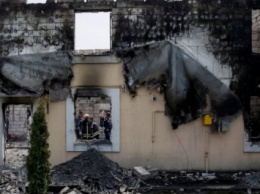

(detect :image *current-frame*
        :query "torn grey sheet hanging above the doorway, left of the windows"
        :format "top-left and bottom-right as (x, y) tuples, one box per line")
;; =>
(0, 52), (73, 100)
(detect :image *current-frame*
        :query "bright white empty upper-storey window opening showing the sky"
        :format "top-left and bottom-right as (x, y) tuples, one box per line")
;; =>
(74, 12), (111, 52)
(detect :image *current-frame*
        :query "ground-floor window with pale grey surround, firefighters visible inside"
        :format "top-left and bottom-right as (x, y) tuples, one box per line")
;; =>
(66, 87), (120, 152)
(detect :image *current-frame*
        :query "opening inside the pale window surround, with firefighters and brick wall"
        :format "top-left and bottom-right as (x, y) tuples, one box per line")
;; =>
(75, 92), (113, 143)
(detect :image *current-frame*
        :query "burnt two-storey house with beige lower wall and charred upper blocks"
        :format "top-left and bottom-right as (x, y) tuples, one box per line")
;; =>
(0, 0), (260, 170)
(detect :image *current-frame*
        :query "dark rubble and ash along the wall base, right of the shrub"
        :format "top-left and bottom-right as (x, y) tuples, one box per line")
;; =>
(52, 149), (260, 193)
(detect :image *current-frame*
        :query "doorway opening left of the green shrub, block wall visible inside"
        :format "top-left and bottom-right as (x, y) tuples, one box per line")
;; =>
(4, 104), (32, 168)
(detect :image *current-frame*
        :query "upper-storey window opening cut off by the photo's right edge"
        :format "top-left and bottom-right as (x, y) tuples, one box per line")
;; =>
(252, 9), (260, 53)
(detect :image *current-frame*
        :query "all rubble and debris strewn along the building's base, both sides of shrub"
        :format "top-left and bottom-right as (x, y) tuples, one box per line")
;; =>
(0, 149), (260, 194)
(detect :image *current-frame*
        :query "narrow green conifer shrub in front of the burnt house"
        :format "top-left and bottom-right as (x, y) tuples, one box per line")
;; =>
(26, 99), (50, 194)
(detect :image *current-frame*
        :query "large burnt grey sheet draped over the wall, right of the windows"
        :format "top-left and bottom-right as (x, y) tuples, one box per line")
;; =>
(117, 41), (241, 129)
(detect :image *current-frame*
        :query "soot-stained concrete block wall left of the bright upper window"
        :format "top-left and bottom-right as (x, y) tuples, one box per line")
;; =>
(0, 3), (74, 56)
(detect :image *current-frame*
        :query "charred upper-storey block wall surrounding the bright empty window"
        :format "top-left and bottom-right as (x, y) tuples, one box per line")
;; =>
(0, 0), (257, 110)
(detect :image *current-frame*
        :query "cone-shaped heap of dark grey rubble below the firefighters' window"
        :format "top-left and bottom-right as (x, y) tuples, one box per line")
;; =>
(51, 149), (139, 192)
